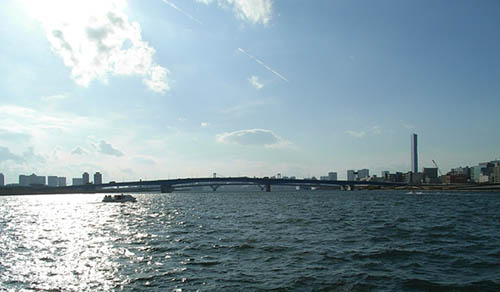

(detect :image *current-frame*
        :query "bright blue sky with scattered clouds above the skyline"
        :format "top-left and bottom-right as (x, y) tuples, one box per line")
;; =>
(0, 0), (500, 183)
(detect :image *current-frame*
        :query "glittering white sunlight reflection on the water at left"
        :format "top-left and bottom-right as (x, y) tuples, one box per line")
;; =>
(0, 195), (150, 291)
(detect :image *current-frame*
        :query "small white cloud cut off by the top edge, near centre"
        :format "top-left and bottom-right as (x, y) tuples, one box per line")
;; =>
(196, 0), (273, 24)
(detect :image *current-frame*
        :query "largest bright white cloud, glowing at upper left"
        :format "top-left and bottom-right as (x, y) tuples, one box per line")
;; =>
(24, 0), (169, 93)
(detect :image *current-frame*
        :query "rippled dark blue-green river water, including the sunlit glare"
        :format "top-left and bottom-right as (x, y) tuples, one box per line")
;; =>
(0, 191), (500, 291)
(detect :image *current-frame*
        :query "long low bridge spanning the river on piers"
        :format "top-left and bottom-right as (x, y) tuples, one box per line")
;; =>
(82, 177), (406, 193)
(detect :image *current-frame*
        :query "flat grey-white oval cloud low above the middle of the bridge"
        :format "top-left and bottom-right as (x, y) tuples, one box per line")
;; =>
(216, 129), (291, 148)
